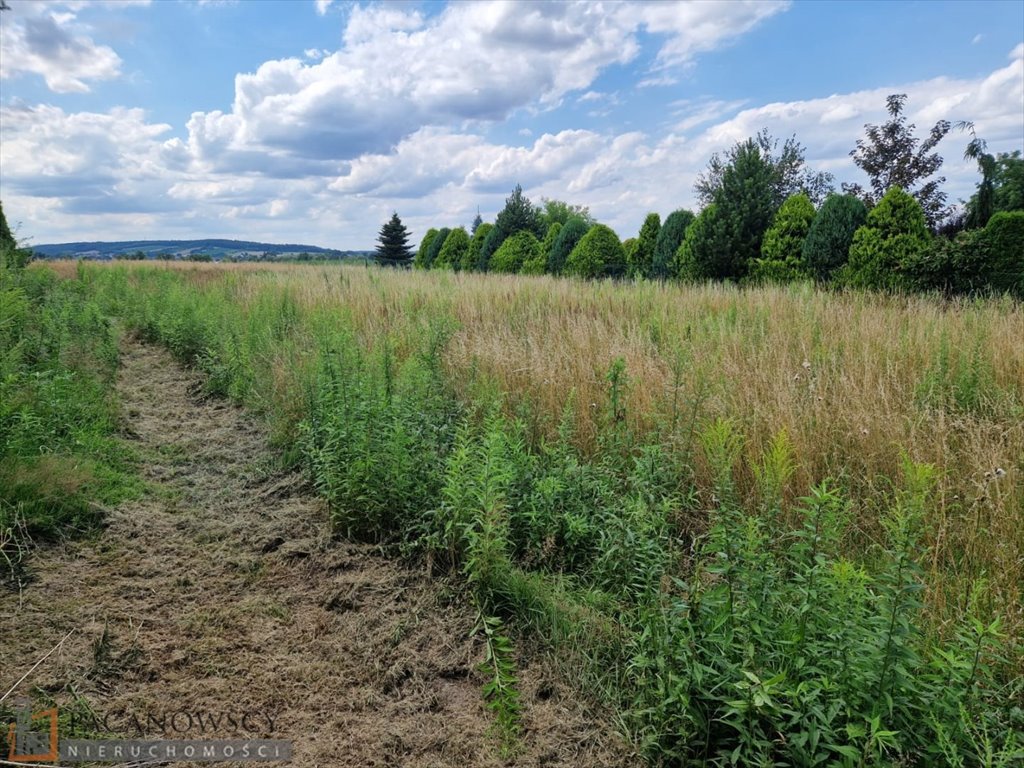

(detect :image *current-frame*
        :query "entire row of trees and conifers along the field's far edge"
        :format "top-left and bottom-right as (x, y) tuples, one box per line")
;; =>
(376, 94), (1024, 296)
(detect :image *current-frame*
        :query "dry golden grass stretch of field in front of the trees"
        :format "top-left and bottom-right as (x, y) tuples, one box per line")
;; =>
(59, 263), (1024, 643)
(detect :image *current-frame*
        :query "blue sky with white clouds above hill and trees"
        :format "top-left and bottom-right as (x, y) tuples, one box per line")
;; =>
(0, 0), (1024, 249)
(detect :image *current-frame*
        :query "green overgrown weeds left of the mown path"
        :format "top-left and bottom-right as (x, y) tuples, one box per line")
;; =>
(0, 246), (134, 588)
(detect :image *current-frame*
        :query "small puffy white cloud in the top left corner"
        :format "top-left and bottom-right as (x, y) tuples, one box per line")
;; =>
(0, 2), (121, 93)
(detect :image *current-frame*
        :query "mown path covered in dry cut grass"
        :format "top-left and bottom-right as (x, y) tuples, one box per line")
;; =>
(0, 341), (626, 768)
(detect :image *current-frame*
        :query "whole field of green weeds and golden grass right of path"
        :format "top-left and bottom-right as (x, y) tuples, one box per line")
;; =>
(59, 264), (1024, 765)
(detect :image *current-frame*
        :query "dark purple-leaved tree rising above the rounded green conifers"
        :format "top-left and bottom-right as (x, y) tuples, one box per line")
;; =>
(843, 93), (952, 229)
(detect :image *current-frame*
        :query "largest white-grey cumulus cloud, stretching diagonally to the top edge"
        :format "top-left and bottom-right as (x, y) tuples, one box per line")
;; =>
(178, 0), (786, 167)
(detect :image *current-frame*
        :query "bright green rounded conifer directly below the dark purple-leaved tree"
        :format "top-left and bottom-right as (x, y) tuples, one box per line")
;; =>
(842, 186), (931, 290)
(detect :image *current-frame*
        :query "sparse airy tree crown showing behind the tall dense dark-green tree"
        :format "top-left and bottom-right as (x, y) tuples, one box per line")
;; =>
(696, 128), (835, 207)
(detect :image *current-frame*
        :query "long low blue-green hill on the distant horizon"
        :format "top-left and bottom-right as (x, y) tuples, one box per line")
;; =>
(32, 240), (373, 261)
